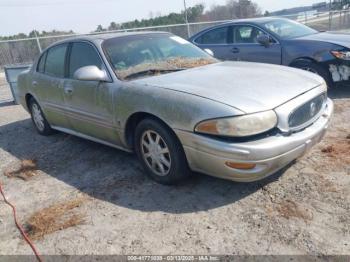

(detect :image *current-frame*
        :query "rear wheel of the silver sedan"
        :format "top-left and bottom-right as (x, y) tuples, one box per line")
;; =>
(29, 98), (54, 136)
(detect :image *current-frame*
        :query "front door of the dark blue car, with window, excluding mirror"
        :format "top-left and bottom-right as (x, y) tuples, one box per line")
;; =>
(232, 25), (282, 64)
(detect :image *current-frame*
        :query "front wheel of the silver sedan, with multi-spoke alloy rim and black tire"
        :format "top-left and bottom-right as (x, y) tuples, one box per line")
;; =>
(134, 119), (190, 185)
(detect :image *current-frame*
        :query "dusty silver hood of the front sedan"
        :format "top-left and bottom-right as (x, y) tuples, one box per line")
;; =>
(133, 62), (323, 113)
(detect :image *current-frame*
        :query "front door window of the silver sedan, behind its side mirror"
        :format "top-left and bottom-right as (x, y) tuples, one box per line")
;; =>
(69, 42), (103, 78)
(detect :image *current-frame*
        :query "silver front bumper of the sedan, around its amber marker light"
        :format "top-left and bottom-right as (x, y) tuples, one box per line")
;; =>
(175, 99), (334, 182)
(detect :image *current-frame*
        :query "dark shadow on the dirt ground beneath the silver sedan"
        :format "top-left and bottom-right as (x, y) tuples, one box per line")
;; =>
(0, 119), (284, 213)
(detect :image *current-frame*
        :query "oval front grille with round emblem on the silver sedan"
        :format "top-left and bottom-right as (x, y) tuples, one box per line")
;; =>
(288, 94), (327, 128)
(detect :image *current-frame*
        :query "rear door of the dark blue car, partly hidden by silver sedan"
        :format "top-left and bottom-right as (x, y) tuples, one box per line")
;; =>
(194, 25), (232, 60)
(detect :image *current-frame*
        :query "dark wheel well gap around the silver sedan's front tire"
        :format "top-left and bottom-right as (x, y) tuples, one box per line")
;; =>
(125, 112), (175, 148)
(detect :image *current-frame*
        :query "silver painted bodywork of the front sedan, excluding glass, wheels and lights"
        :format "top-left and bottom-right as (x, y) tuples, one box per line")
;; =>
(18, 33), (333, 181)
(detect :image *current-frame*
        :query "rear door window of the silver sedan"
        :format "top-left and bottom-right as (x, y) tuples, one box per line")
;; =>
(45, 44), (68, 78)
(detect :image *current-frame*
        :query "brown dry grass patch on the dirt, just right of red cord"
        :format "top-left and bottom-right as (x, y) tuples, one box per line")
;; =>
(26, 198), (86, 240)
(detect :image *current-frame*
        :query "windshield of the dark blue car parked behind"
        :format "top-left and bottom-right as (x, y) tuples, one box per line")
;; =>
(263, 19), (318, 39)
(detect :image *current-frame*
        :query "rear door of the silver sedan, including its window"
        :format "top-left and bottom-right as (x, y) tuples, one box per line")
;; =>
(32, 43), (69, 128)
